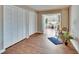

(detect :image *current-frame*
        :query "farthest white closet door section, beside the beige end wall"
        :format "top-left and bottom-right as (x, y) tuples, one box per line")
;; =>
(29, 11), (37, 35)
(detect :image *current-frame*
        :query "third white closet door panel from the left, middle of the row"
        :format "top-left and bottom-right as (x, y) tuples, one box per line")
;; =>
(17, 8), (23, 40)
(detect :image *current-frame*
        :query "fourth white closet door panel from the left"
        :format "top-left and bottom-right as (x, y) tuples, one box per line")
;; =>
(23, 9), (29, 38)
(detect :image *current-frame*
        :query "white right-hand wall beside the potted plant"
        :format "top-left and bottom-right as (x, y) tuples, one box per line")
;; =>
(70, 5), (79, 52)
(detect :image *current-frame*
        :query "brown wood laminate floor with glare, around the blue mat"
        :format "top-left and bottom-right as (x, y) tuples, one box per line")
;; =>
(3, 34), (77, 54)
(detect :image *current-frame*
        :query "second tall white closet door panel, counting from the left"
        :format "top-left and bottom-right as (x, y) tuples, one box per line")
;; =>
(11, 6), (18, 44)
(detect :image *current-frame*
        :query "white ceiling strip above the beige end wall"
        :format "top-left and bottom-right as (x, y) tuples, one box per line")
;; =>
(28, 5), (69, 11)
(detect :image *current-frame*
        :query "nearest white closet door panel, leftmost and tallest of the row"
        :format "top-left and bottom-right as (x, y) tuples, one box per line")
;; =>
(3, 6), (12, 48)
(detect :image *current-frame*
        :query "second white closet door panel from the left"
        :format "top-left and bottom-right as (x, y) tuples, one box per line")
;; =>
(10, 6), (18, 44)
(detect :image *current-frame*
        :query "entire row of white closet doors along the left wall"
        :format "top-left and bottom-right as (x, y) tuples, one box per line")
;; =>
(4, 5), (36, 48)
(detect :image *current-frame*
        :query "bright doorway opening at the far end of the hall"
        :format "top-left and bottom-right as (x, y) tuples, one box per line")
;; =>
(42, 13), (61, 37)
